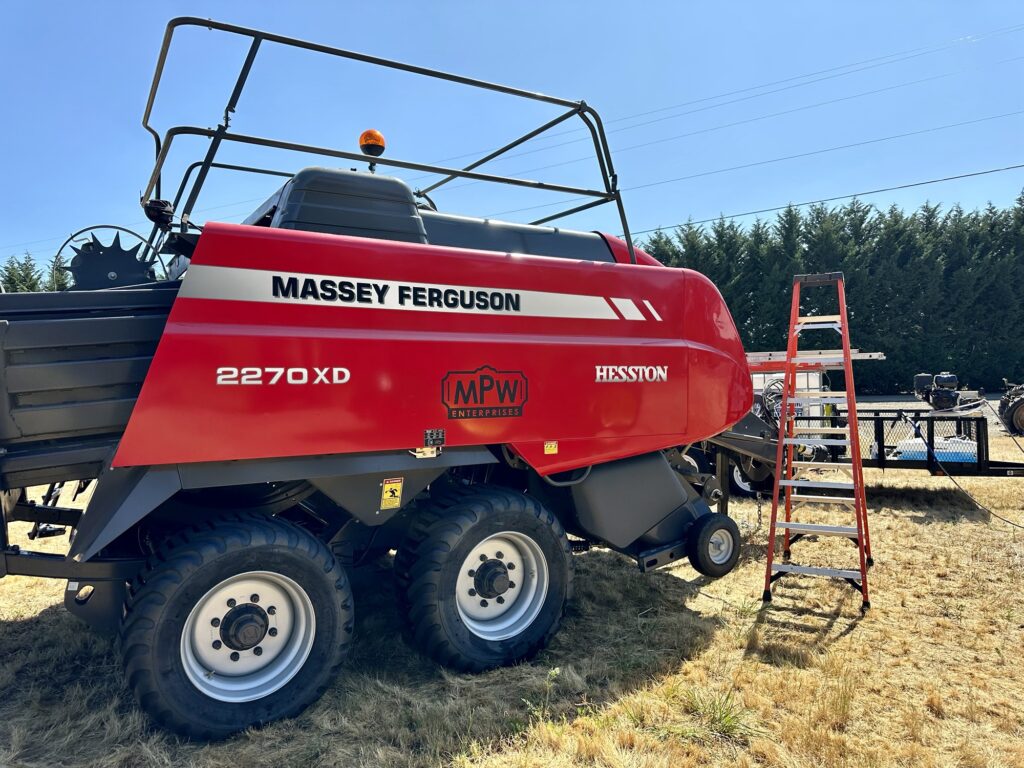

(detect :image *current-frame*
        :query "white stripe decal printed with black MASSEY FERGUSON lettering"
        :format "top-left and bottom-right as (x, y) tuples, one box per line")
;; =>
(178, 264), (618, 319)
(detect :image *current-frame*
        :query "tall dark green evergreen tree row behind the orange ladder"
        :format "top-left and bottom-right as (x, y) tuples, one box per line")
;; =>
(640, 194), (1024, 394)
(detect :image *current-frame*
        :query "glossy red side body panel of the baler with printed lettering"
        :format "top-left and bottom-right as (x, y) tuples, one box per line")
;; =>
(114, 223), (753, 474)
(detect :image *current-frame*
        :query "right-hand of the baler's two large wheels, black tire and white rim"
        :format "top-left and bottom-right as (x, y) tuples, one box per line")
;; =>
(407, 488), (572, 672)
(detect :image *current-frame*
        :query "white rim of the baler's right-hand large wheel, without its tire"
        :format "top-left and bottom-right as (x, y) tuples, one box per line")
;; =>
(456, 530), (550, 641)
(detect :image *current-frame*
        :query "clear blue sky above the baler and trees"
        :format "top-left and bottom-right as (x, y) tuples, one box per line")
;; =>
(0, 0), (1024, 259)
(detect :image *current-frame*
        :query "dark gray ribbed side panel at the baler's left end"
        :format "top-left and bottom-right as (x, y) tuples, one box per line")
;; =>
(0, 284), (177, 488)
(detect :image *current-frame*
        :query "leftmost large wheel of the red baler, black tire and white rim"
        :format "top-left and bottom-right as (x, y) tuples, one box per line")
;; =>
(121, 514), (353, 739)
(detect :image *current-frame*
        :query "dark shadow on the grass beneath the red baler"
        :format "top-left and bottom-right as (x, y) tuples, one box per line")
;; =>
(0, 551), (719, 766)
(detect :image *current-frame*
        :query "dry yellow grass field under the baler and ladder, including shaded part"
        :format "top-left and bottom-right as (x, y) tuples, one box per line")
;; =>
(0, 411), (1024, 768)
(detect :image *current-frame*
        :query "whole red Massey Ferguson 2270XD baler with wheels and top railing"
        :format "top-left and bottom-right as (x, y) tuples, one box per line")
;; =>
(0, 18), (752, 737)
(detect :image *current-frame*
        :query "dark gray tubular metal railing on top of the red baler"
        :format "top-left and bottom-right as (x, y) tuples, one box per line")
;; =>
(141, 16), (636, 263)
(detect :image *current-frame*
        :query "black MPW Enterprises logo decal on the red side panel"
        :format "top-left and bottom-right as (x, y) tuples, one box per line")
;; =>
(441, 366), (527, 419)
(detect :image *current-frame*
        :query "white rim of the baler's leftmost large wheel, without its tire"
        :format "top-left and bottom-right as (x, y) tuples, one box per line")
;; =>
(181, 570), (316, 703)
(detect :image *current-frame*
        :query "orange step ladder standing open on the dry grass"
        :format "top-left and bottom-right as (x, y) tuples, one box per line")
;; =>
(762, 272), (873, 610)
